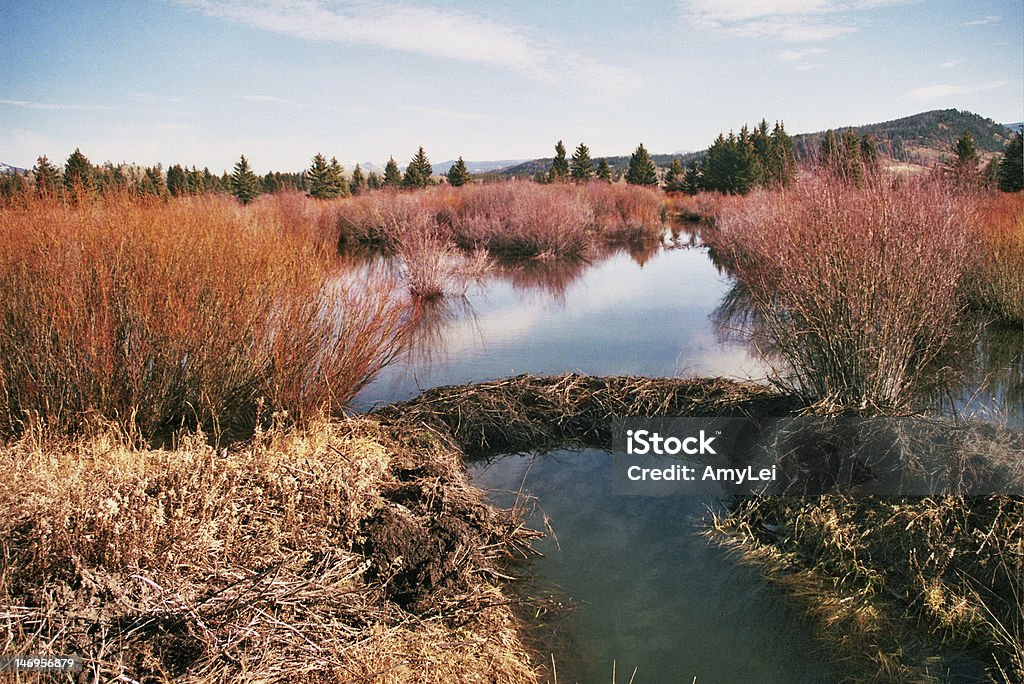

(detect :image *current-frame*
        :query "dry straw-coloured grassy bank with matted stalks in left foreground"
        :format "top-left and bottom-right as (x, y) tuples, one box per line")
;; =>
(0, 420), (537, 682)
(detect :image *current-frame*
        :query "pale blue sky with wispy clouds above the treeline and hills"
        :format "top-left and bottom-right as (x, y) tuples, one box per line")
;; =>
(0, 0), (1024, 172)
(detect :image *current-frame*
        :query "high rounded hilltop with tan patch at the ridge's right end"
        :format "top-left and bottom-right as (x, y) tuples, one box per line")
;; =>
(793, 110), (1012, 164)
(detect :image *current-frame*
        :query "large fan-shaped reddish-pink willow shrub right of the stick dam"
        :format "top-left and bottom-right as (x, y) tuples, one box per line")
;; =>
(707, 174), (974, 411)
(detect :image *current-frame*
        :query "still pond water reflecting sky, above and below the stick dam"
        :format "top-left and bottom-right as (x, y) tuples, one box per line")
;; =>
(356, 233), (1024, 682)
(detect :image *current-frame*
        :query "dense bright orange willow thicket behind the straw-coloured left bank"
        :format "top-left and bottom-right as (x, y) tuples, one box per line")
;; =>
(0, 197), (410, 437)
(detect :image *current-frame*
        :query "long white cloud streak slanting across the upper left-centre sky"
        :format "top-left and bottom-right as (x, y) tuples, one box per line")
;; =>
(178, 0), (636, 89)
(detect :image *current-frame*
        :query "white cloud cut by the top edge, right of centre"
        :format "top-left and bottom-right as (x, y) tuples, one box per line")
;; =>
(681, 0), (908, 43)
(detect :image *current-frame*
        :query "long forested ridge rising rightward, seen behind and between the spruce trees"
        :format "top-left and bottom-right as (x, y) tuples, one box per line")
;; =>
(501, 110), (1012, 176)
